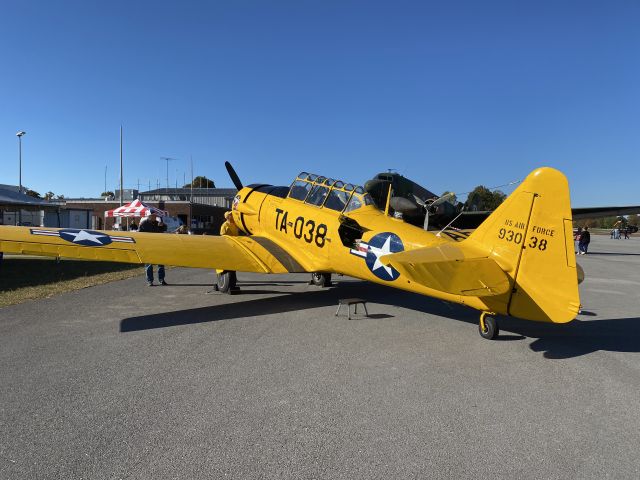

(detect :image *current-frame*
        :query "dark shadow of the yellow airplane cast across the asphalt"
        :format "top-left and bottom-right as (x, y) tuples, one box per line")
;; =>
(120, 281), (640, 359)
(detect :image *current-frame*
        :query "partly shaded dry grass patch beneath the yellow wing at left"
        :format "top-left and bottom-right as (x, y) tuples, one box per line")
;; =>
(0, 255), (144, 307)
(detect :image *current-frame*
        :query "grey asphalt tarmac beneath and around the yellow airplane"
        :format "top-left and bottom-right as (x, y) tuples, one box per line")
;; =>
(0, 236), (640, 480)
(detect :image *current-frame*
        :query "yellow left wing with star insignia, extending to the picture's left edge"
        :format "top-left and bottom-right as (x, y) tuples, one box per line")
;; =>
(0, 226), (304, 273)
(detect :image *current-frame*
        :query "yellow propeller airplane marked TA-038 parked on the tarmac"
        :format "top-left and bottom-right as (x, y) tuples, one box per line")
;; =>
(0, 165), (581, 339)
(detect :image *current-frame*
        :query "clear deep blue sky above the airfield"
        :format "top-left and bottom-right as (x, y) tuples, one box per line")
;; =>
(0, 0), (640, 206)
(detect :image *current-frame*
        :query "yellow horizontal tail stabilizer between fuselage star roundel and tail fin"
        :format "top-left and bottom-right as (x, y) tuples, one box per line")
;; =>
(380, 244), (511, 297)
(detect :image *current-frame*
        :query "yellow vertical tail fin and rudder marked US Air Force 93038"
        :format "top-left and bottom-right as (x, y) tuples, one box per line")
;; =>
(467, 167), (580, 323)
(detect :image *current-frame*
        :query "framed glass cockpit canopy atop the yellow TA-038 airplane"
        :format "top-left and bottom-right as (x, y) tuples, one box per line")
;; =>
(289, 172), (374, 213)
